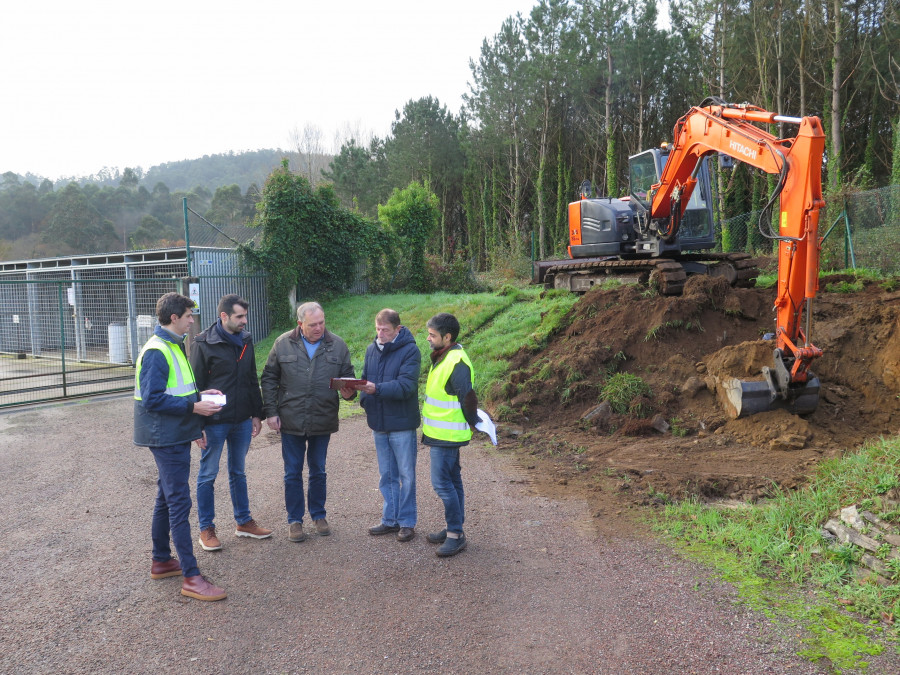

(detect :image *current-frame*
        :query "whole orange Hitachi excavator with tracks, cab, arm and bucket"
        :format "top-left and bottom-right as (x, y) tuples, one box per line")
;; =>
(535, 98), (825, 417)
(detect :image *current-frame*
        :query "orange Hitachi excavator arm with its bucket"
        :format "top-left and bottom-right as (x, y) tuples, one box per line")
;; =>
(648, 100), (825, 417)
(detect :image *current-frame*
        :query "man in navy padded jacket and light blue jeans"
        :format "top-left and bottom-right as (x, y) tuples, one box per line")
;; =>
(359, 309), (422, 541)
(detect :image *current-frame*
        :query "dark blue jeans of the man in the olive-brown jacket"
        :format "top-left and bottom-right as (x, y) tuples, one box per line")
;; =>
(281, 431), (331, 523)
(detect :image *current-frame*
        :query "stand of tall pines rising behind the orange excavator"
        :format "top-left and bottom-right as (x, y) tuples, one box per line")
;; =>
(325, 0), (900, 269)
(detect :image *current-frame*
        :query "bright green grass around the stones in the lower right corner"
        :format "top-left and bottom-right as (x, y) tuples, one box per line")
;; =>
(657, 438), (900, 670)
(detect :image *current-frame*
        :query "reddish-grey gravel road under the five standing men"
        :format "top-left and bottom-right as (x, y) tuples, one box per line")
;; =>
(0, 398), (884, 674)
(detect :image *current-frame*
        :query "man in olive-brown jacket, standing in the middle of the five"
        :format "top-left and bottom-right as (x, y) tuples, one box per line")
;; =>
(260, 302), (356, 542)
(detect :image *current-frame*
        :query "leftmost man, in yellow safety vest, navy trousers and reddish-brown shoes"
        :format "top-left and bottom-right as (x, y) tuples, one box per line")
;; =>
(134, 293), (226, 600)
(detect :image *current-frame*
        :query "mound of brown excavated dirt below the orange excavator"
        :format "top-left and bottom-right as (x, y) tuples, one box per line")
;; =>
(495, 276), (900, 510)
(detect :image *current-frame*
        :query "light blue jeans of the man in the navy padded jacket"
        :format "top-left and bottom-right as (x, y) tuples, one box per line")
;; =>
(372, 429), (418, 527)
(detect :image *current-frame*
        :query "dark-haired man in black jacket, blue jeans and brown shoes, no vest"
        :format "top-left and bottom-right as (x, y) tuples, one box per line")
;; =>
(191, 294), (272, 551)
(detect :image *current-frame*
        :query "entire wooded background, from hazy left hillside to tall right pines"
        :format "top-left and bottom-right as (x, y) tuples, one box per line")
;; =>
(0, 0), (900, 278)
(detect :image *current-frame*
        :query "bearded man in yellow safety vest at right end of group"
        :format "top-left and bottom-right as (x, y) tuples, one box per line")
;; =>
(422, 312), (478, 557)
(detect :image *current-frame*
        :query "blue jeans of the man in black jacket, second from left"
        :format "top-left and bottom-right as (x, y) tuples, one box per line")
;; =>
(197, 417), (253, 530)
